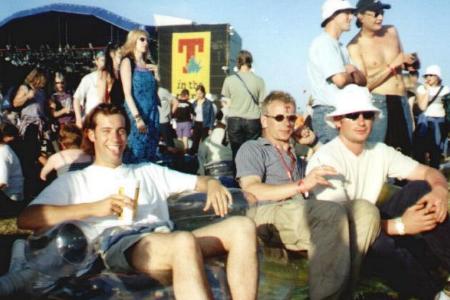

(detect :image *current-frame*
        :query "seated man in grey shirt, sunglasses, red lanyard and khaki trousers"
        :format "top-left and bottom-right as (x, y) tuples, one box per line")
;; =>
(236, 91), (380, 299)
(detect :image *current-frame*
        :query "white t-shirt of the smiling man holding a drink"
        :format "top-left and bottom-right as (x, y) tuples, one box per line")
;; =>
(30, 163), (197, 234)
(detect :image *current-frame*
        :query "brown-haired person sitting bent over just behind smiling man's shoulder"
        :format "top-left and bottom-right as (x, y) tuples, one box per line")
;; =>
(40, 123), (92, 181)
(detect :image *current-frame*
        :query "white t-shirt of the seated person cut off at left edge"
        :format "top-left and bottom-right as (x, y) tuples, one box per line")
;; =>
(0, 144), (23, 201)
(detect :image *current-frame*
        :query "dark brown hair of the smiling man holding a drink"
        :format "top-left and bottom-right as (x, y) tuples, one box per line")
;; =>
(81, 103), (131, 155)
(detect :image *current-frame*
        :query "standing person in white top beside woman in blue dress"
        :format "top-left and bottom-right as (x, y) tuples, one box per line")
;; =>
(73, 51), (105, 128)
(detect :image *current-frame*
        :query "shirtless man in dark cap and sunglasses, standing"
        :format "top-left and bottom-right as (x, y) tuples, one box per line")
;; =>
(348, 0), (417, 154)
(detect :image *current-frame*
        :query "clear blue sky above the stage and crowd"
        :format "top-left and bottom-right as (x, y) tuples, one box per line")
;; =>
(0, 0), (450, 110)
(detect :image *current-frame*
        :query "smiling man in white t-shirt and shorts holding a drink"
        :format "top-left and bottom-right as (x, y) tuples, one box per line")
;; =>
(18, 104), (258, 299)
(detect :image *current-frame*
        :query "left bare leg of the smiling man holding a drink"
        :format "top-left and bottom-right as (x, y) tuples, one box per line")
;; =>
(126, 232), (212, 299)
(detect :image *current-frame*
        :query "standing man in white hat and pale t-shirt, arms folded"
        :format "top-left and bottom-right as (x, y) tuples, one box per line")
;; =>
(307, 0), (366, 143)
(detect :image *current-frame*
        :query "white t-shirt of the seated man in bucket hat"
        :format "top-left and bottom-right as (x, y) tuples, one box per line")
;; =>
(306, 137), (419, 203)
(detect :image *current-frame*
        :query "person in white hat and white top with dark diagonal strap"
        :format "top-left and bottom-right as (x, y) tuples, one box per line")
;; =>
(413, 65), (450, 169)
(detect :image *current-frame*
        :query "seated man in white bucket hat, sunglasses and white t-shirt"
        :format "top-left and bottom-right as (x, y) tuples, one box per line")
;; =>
(306, 85), (450, 299)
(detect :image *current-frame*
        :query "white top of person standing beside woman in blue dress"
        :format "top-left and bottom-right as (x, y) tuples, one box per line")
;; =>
(73, 71), (100, 116)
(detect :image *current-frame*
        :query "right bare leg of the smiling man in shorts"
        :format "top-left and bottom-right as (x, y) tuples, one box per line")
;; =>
(193, 217), (258, 299)
